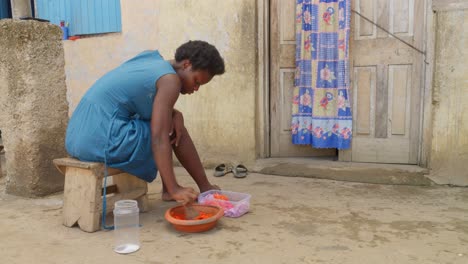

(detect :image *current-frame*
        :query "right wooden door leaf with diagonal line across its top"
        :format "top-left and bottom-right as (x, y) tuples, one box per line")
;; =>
(350, 0), (425, 164)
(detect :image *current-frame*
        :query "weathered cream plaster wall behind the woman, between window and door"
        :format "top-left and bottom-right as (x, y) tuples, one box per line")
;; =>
(64, 0), (257, 165)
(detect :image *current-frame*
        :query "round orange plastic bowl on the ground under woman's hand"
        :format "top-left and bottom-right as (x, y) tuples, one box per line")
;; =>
(164, 204), (224, 233)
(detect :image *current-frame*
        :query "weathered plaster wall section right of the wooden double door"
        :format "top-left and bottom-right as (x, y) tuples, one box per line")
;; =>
(430, 9), (468, 185)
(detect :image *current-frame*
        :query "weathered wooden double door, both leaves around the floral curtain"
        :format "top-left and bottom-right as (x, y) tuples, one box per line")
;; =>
(267, 0), (426, 164)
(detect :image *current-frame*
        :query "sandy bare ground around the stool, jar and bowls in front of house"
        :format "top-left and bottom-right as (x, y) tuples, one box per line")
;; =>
(0, 168), (468, 264)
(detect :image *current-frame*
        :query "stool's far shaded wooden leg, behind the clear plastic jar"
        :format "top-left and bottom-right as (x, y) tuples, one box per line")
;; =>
(112, 173), (149, 212)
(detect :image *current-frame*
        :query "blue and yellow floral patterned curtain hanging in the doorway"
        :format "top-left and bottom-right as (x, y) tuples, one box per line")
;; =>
(291, 0), (352, 149)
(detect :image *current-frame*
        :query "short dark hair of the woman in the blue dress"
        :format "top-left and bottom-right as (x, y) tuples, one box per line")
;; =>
(175, 40), (224, 76)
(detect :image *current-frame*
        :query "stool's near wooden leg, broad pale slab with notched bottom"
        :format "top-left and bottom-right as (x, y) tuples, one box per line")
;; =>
(63, 167), (102, 232)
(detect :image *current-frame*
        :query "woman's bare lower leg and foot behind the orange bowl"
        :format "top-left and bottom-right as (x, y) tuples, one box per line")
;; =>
(162, 129), (219, 201)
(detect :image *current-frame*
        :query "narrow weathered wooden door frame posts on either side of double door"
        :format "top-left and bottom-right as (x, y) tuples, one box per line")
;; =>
(255, 0), (437, 167)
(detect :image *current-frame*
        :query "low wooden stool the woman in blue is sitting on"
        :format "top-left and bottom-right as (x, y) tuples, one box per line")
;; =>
(54, 158), (148, 232)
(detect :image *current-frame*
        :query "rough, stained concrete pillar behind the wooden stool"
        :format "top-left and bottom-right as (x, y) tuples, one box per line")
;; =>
(0, 19), (68, 196)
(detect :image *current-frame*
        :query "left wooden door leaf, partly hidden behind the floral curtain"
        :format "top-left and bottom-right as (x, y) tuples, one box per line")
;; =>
(270, 0), (336, 157)
